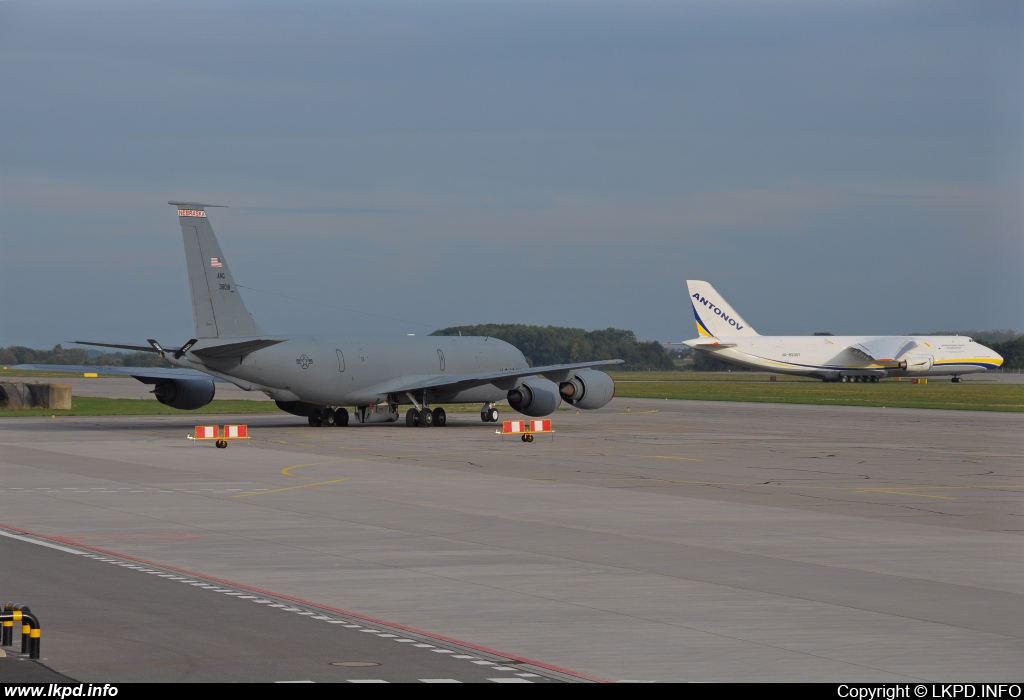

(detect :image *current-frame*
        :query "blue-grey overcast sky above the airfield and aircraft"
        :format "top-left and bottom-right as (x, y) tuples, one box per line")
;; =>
(0, 0), (1024, 348)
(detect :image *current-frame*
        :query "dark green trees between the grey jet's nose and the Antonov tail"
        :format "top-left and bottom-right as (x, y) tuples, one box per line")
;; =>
(430, 323), (675, 371)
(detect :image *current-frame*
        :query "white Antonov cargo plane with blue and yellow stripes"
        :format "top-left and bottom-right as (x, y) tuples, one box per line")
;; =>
(682, 279), (1002, 383)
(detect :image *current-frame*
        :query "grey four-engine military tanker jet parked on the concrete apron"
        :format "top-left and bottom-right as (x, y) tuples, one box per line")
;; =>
(76, 202), (623, 427)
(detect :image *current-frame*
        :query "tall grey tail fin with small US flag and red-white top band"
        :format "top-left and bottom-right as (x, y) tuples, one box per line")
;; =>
(168, 202), (263, 338)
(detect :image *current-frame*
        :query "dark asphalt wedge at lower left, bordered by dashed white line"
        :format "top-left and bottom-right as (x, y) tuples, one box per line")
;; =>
(0, 531), (560, 684)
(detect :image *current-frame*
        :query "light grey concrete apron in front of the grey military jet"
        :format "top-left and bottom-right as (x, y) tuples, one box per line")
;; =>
(0, 399), (1024, 683)
